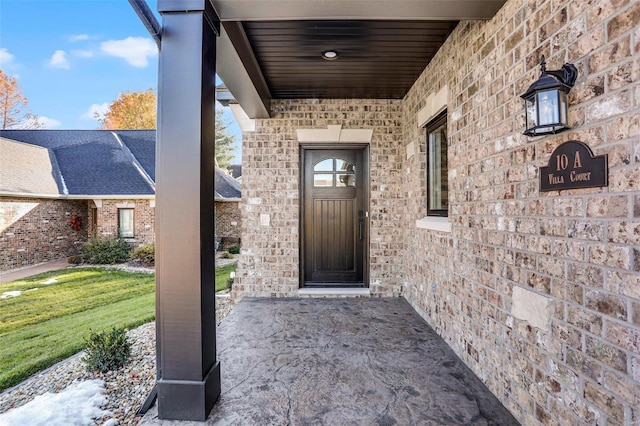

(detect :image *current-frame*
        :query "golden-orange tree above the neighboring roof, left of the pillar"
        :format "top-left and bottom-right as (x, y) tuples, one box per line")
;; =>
(96, 89), (156, 130)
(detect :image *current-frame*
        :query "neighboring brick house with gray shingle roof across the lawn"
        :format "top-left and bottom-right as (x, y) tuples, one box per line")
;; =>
(0, 130), (240, 271)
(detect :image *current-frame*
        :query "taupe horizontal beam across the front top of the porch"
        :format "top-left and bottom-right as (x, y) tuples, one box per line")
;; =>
(211, 0), (506, 22)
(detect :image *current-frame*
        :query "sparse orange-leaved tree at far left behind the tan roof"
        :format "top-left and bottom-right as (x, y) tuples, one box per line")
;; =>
(0, 70), (42, 130)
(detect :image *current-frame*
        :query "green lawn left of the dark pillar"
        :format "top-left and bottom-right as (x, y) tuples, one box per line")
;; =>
(0, 268), (155, 390)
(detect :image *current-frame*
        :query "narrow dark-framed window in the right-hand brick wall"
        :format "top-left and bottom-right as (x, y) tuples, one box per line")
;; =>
(426, 110), (449, 217)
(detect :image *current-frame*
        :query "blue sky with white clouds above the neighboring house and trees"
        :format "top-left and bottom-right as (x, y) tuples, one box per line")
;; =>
(0, 0), (240, 161)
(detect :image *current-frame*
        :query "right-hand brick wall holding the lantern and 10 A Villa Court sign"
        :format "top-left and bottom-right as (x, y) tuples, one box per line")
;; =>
(403, 0), (640, 425)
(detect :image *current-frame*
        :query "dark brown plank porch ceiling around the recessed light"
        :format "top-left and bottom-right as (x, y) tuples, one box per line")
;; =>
(238, 20), (458, 99)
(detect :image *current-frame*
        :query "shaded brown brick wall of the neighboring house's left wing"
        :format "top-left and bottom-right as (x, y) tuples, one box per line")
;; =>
(0, 197), (88, 271)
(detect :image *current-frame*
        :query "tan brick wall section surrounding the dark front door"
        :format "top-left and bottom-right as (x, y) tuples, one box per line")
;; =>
(233, 99), (404, 297)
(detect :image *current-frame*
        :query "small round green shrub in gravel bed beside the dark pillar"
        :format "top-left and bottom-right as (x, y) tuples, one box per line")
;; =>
(82, 327), (131, 373)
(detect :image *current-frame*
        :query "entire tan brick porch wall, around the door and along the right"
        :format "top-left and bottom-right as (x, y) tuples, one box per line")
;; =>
(234, 0), (640, 425)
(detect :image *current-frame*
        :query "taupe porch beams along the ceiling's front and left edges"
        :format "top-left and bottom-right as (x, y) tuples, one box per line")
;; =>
(212, 0), (506, 119)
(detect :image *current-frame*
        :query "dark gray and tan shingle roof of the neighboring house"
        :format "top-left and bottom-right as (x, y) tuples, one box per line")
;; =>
(0, 130), (241, 199)
